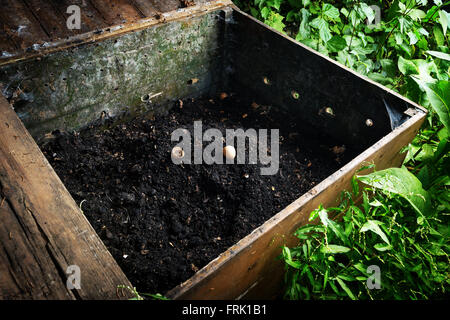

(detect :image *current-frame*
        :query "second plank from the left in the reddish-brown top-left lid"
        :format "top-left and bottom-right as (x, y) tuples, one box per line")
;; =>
(23, 0), (73, 40)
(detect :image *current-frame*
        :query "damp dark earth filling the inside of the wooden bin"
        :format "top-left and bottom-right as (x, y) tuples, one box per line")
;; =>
(40, 94), (357, 293)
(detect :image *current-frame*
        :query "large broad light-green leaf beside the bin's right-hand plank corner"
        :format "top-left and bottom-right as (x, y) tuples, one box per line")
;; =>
(357, 167), (431, 215)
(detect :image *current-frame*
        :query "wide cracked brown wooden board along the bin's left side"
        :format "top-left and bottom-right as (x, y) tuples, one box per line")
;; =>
(0, 97), (134, 299)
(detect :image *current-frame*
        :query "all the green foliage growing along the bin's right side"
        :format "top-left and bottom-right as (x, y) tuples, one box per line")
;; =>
(235, 0), (450, 299)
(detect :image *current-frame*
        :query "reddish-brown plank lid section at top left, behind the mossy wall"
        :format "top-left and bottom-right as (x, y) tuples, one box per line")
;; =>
(0, 0), (232, 66)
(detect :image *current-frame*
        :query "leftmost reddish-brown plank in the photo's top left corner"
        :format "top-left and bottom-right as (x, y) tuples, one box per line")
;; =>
(0, 0), (49, 49)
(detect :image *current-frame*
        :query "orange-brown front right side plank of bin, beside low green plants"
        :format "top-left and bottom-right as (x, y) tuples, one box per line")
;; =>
(167, 110), (425, 299)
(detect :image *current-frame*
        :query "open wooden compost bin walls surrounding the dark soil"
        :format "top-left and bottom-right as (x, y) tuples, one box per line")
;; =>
(0, 1), (426, 299)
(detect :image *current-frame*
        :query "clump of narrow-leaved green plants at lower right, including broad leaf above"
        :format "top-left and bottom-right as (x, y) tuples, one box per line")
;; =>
(281, 168), (450, 300)
